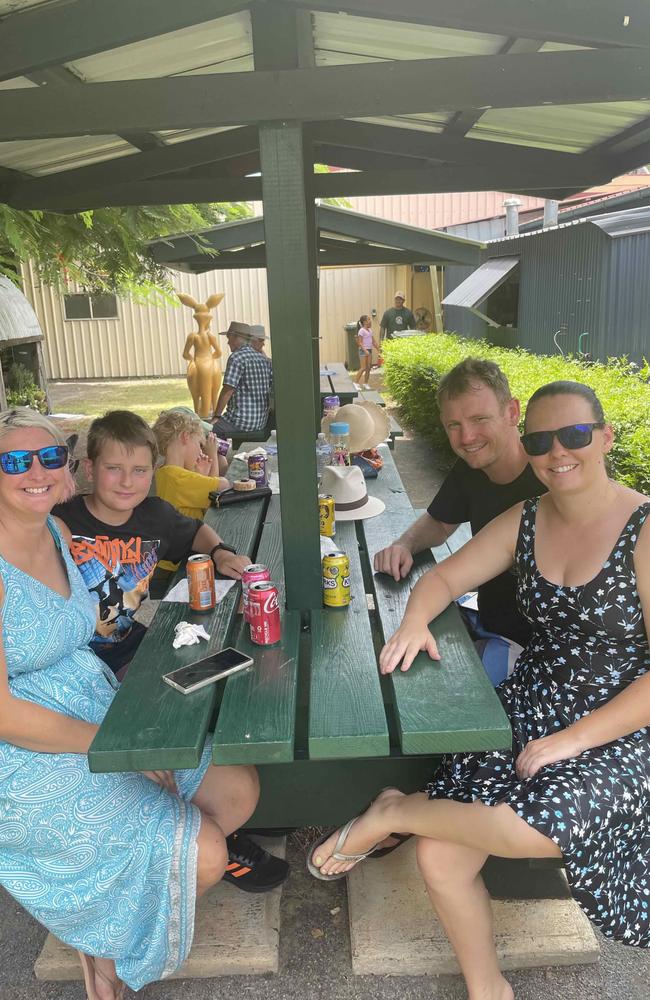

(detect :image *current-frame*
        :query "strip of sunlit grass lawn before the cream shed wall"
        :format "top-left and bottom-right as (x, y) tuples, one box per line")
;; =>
(49, 378), (192, 424)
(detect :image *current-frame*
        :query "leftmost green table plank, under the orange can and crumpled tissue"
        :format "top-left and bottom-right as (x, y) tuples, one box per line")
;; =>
(88, 501), (266, 772)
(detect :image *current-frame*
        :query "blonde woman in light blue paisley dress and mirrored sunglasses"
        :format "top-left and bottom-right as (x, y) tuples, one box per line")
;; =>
(0, 409), (258, 1000)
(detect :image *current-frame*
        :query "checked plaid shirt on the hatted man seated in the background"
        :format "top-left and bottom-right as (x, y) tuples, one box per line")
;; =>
(223, 344), (273, 431)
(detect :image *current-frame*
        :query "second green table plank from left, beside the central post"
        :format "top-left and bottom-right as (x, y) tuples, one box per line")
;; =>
(212, 496), (300, 764)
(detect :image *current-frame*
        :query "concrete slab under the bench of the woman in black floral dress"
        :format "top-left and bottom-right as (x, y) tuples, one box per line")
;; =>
(348, 841), (599, 976)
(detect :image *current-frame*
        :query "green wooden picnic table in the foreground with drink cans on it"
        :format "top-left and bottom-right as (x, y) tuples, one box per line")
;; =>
(88, 445), (511, 826)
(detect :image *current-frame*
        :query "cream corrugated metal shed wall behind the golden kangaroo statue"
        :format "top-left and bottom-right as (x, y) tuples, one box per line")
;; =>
(23, 265), (402, 379)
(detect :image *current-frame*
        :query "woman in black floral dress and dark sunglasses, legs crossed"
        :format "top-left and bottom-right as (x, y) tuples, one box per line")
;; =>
(310, 382), (650, 1000)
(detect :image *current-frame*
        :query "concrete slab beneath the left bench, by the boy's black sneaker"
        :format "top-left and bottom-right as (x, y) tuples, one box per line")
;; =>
(34, 837), (286, 980)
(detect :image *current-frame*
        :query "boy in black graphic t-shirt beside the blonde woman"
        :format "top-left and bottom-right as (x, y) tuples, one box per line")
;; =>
(52, 410), (289, 892)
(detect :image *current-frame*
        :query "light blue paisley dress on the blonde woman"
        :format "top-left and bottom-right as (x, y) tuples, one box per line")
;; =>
(0, 518), (209, 990)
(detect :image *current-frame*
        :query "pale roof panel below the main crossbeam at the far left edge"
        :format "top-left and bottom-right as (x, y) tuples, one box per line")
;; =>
(0, 135), (138, 177)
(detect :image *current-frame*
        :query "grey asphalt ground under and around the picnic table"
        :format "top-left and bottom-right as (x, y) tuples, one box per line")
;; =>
(0, 386), (650, 1000)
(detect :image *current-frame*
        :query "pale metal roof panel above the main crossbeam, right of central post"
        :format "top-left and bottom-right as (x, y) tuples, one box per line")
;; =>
(312, 12), (506, 66)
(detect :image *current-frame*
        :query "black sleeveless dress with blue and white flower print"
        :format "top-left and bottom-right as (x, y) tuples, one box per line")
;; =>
(428, 500), (650, 948)
